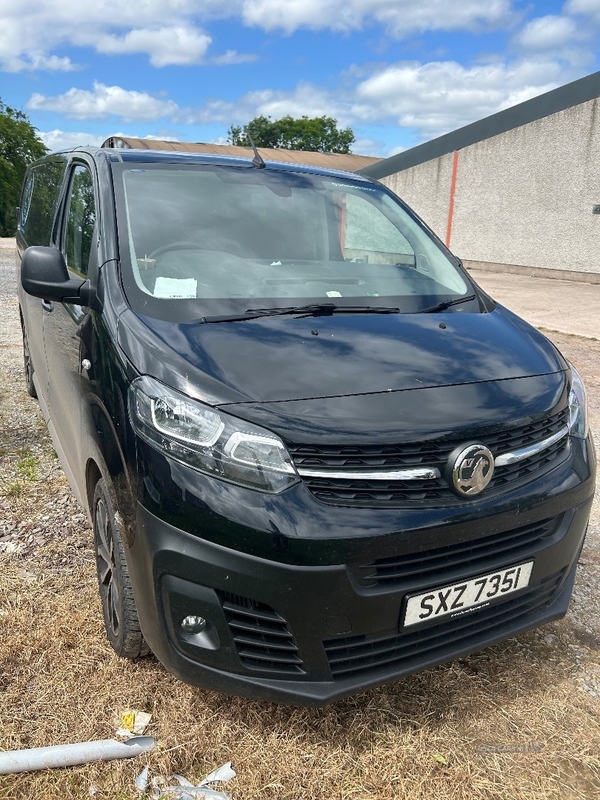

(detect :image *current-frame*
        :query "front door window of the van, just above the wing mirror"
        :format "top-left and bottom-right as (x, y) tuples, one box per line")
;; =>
(63, 166), (96, 275)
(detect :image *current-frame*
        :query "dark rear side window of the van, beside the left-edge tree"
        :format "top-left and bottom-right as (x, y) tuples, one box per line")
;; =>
(19, 159), (65, 247)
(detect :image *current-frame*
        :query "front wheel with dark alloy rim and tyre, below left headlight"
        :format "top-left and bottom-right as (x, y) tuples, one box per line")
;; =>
(93, 479), (150, 658)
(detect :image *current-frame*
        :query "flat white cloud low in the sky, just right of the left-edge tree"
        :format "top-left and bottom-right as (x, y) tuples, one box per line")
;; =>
(27, 82), (178, 121)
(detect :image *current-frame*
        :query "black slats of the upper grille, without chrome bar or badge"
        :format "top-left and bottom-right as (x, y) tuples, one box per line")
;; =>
(288, 408), (568, 508)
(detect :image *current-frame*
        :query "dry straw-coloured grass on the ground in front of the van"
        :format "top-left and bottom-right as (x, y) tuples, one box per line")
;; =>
(0, 536), (600, 800)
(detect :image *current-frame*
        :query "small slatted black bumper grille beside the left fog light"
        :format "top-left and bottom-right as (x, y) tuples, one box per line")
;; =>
(221, 592), (304, 676)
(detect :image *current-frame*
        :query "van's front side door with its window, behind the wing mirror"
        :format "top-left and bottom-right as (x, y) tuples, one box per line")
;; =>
(44, 162), (97, 507)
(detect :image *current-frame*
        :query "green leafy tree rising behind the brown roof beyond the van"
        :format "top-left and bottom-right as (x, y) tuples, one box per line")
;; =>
(227, 115), (356, 153)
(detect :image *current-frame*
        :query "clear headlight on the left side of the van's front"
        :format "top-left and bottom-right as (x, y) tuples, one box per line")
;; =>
(129, 376), (299, 494)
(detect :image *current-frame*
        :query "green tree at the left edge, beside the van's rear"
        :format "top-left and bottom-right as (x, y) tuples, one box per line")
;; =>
(0, 100), (47, 236)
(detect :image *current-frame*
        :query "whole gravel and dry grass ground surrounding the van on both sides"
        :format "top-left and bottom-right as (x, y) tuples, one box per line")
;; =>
(0, 242), (600, 800)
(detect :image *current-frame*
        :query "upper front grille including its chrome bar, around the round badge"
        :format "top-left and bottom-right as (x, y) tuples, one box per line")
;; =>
(286, 406), (570, 508)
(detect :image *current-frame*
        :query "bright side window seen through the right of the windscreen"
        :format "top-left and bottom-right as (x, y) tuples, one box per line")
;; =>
(342, 194), (415, 266)
